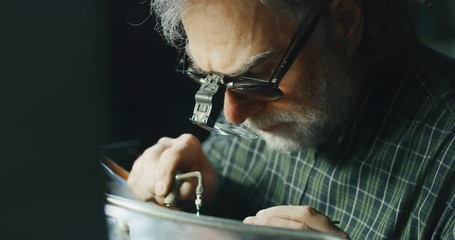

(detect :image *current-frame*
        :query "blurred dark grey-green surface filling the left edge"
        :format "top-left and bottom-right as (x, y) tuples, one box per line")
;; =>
(0, 0), (111, 240)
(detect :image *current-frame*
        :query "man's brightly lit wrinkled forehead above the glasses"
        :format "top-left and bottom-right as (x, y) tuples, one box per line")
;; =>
(182, 0), (294, 74)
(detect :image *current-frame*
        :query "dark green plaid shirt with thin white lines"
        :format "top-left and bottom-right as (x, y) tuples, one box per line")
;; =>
(204, 44), (455, 239)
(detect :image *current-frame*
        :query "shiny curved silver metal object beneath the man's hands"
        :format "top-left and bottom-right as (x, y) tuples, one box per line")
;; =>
(105, 194), (340, 240)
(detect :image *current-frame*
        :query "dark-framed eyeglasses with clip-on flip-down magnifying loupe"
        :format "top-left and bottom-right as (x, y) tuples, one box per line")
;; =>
(175, 4), (324, 138)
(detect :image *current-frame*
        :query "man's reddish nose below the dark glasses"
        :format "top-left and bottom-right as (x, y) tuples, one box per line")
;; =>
(224, 90), (265, 124)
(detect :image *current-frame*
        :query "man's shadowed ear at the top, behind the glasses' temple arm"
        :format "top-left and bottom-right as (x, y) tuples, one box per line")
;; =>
(328, 0), (364, 58)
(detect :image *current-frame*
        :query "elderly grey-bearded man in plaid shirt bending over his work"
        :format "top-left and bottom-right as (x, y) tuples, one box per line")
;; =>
(128, 0), (455, 239)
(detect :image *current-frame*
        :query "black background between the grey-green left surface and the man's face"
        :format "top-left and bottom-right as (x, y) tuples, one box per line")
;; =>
(107, 0), (214, 170)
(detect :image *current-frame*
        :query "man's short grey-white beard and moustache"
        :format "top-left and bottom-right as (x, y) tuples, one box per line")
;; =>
(245, 41), (358, 151)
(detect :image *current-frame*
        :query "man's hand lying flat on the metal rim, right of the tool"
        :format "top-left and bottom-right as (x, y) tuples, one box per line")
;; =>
(243, 206), (349, 239)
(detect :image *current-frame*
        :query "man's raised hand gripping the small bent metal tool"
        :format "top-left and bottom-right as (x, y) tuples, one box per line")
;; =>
(128, 134), (217, 207)
